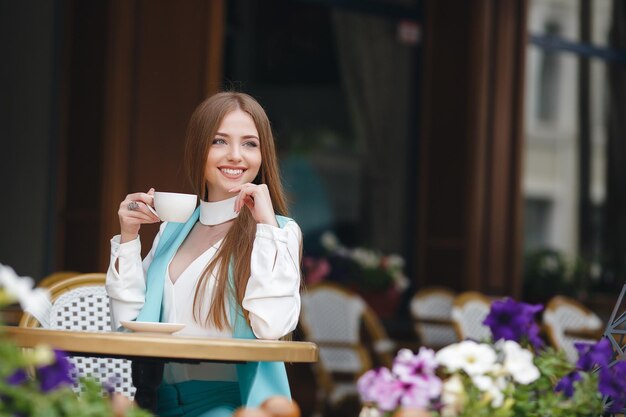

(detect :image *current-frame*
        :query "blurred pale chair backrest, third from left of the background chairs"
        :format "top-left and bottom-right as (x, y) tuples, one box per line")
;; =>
(452, 291), (491, 341)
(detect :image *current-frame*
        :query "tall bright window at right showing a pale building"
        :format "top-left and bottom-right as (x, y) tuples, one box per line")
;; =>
(523, 0), (626, 300)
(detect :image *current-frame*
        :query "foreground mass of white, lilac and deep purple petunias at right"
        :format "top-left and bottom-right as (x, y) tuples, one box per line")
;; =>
(358, 299), (626, 417)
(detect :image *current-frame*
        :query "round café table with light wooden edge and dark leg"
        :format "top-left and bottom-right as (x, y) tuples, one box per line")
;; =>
(0, 326), (318, 410)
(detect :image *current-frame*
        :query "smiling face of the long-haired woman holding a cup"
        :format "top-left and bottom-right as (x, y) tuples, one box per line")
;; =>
(204, 109), (261, 201)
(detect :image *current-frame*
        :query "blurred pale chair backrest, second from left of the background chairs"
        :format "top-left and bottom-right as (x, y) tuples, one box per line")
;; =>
(410, 287), (458, 349)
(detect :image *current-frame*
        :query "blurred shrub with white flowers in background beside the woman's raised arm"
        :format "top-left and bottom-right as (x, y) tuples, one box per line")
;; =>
(303, 232), (409, 292)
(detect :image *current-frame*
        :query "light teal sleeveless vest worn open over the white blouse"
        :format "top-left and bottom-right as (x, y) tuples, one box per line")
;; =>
(136, 208), (291, 407)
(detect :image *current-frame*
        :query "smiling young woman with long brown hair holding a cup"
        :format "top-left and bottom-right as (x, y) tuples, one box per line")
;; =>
(106, 92), (302, 417)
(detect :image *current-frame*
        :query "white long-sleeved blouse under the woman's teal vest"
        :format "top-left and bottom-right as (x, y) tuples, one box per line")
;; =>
(106, 199), (302, 383)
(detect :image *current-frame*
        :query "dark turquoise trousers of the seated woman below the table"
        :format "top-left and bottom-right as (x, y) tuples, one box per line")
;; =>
(157, 381), (241, 417)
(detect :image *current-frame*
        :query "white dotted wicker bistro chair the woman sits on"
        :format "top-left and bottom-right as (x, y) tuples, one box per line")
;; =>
(20, 273), (135, 399)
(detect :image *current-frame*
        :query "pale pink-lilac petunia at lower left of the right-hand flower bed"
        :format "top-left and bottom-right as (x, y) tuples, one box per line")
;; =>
(357, 368), (404, 411)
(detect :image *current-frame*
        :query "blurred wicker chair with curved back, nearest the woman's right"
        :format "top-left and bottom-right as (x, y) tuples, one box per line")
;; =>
(300, 283), (395, 415)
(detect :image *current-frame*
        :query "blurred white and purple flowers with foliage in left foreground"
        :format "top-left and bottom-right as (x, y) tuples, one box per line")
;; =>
(0, 264), (150, 417)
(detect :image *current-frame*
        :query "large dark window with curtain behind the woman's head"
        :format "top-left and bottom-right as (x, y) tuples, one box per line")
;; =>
(225, 0), (417, 268)
